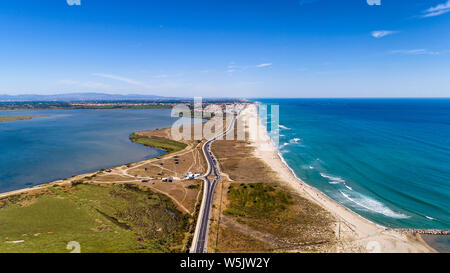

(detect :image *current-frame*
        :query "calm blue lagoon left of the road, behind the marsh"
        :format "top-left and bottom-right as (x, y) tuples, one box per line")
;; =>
(0, 109), (179, 192)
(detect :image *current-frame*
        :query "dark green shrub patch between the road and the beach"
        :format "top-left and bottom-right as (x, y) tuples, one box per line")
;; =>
(225, 183), (293, 217)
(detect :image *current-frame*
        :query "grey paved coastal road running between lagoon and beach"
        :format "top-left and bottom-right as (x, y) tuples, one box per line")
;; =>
(191, 113), (236, 253)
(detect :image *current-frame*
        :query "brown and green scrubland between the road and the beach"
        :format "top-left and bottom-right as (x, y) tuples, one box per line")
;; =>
(211, 183), (335, 252)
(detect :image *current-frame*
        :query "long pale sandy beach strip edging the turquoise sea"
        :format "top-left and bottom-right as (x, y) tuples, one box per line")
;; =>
(241, 105), (436, 253)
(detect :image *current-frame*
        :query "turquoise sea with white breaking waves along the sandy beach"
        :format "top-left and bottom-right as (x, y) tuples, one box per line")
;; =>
(257, 99), (450, 229)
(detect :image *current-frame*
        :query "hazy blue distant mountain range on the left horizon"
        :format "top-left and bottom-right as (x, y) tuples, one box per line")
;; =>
(0, 93), (174, 102)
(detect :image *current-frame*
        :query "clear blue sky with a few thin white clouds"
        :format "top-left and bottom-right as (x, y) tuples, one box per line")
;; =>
(0, 0), (450, 97)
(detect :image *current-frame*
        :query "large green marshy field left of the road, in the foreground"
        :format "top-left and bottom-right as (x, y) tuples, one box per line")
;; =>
(0, 184), (190, 253)
